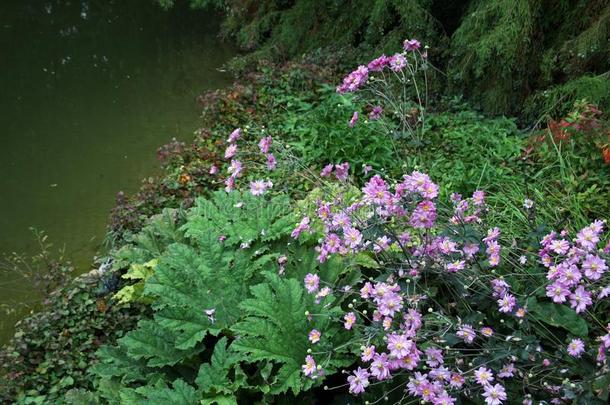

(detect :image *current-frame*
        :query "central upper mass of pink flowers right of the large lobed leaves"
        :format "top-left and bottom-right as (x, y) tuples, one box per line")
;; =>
(292, 170), (499, 275)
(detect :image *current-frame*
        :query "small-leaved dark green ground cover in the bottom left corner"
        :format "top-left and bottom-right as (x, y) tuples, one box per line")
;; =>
(0, 278), (146, 403)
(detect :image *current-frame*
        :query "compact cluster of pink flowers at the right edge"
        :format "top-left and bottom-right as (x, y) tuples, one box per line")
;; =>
(538, 221), (608, 313)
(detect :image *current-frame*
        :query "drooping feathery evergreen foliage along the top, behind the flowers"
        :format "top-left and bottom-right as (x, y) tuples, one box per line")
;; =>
(163, 0), (610, 123)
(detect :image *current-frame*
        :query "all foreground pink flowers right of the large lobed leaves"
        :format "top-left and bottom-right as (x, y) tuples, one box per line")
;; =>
(292, 165), (610, 405)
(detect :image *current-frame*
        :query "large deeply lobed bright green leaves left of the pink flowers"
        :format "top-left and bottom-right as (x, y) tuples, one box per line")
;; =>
(93, 191), (352, 403)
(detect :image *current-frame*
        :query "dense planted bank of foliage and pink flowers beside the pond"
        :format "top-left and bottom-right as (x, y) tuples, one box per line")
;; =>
(0, 1), (610, 405)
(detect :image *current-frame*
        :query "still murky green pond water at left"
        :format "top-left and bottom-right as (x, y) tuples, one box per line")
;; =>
(0, 0), (235, 343)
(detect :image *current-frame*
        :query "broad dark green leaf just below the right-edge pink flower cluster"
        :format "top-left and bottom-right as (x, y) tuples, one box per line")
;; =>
(527, 297), (589, 337)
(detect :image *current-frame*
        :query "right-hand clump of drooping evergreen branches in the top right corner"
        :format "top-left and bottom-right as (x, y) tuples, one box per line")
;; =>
(448, 0), (610, 117)
